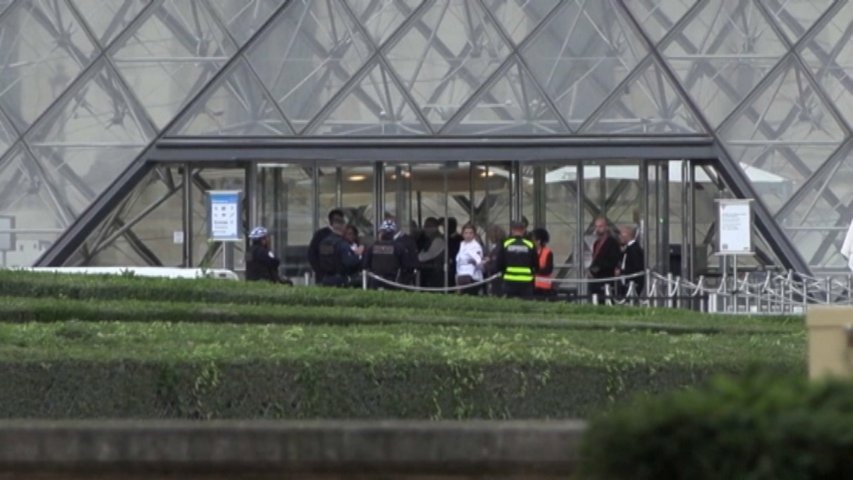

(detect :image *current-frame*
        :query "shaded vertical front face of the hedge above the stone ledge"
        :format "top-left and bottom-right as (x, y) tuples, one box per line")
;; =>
(0, 361), (756, 419)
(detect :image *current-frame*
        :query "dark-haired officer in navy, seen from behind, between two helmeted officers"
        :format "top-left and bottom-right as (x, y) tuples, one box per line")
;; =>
(317, 218), (364, 287)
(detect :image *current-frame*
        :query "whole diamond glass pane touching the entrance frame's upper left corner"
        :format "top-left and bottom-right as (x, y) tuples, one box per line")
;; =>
(27, 60), (154, 215)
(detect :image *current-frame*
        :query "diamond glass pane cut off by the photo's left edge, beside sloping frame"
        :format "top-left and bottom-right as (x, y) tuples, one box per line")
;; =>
(0, 146), (68, 267)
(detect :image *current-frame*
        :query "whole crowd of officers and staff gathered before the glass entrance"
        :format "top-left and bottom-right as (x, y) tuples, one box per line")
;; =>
(246, 209), (645, 299)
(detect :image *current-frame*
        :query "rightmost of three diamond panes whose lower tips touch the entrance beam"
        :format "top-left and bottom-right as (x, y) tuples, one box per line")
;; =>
(522, 0), (648, 129)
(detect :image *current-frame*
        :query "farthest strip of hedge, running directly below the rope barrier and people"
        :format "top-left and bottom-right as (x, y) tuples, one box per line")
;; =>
(0, 271), (803, 328)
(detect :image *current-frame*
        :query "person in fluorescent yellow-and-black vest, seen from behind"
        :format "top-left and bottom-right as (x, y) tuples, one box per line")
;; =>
(496, 220), (539, 298)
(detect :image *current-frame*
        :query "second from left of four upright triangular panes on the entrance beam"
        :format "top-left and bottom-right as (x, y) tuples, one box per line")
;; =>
(310, 64), (429, 136)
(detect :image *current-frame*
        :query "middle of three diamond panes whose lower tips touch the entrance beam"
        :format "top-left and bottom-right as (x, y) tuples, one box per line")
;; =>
(386, 0), (510, 129)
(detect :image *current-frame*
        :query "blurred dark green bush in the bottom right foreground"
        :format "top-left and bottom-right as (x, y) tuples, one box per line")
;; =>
(582, 373), (853, 480)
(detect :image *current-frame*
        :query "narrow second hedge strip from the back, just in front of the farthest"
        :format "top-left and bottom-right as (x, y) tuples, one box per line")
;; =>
(0, 297), (802, 334)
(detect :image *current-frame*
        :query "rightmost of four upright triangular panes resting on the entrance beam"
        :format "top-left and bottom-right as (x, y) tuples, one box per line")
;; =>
(583, 62), (704, 134)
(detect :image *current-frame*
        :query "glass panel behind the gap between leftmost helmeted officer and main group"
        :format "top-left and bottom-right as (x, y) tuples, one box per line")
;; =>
(259, 165), (316, 280)
